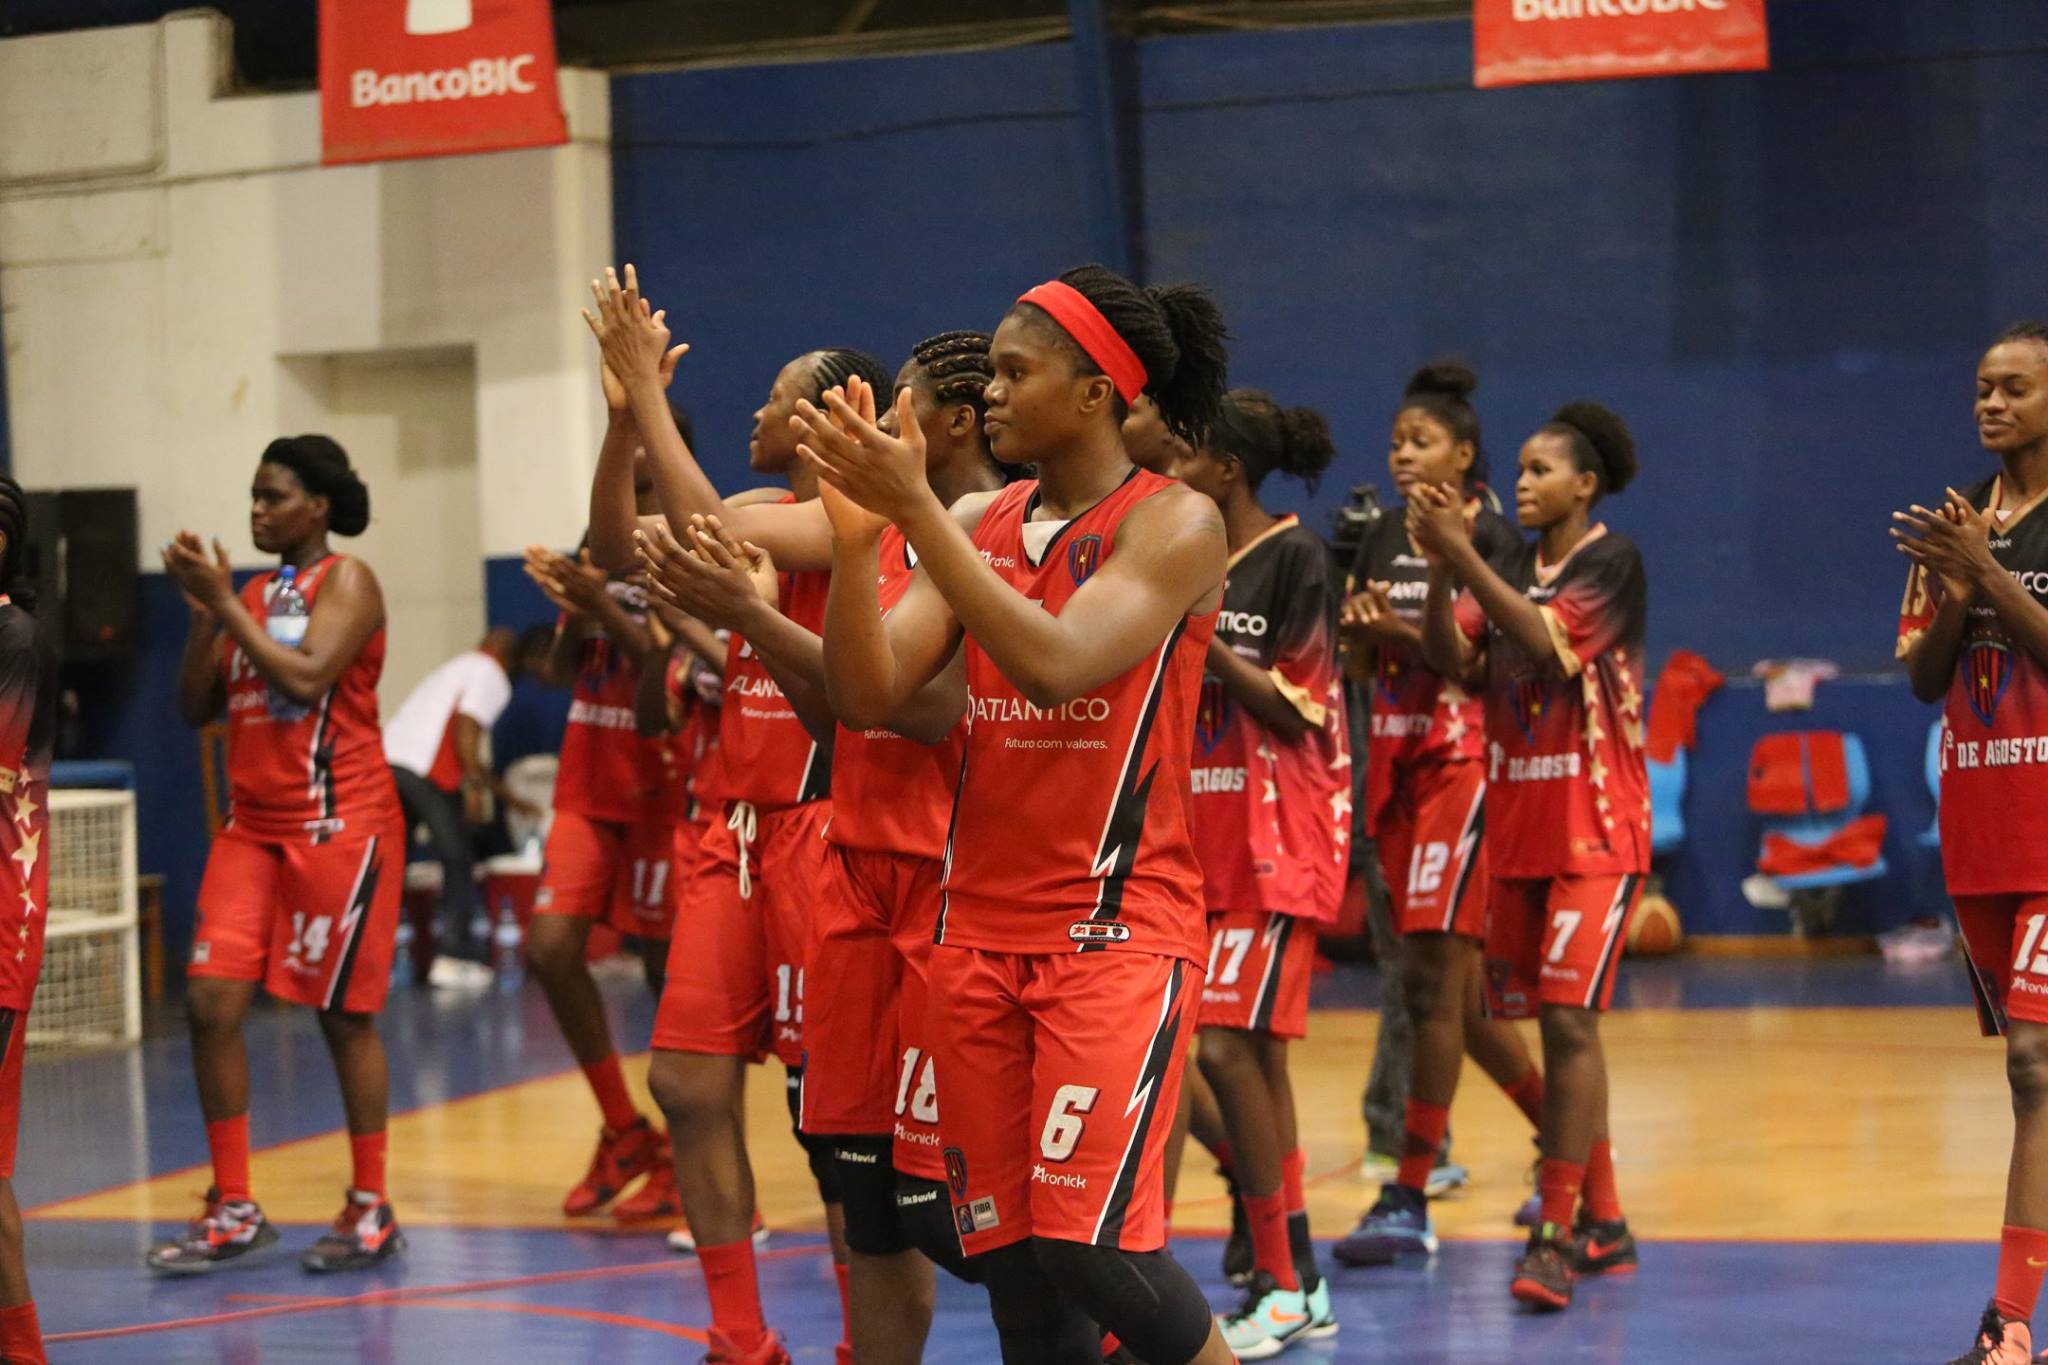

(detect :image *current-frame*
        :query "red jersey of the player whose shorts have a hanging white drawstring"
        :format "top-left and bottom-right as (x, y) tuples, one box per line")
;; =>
(696, 571), (831, 810)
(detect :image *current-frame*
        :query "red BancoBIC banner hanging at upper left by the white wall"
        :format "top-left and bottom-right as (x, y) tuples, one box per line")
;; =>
(319, 0), (569, 166)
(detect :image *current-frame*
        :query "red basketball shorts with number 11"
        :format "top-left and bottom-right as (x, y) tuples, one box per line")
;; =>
(532, 810), (680, 939)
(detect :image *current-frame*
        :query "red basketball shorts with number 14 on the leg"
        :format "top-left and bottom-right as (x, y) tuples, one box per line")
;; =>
(186, 827), (406, 1013)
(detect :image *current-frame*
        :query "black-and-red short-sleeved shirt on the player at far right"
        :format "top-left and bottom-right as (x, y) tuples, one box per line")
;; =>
(1898, 479), (2048, 896)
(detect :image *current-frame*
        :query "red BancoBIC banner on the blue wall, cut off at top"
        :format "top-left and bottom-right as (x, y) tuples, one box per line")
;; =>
(1473, 0), (1772, 86)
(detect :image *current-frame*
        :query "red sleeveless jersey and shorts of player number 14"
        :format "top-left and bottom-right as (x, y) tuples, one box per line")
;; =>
(186, 555), (406, 1013)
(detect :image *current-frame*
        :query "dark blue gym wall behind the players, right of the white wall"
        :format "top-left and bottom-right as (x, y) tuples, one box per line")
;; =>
(612, 0), (2048, 933)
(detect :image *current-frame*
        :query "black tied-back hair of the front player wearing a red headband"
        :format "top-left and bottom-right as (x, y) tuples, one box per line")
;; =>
(1016, 266), (1231, 446)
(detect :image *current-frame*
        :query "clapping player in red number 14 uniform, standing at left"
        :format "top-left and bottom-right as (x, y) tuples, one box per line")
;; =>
(150, 436), (406, 1275)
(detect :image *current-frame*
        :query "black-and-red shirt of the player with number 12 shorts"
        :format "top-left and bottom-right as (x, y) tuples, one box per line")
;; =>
(1364, 503), (1518, 835)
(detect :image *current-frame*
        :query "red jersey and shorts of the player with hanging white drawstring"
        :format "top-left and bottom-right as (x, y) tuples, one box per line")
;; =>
(653, 532), (831, 1068)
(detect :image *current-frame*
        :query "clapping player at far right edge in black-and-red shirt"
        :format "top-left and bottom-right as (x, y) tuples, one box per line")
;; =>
(1892, 323), (2048, 1365)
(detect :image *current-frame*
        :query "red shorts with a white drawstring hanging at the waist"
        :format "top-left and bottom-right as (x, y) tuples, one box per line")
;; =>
(653, 800), (831, 1066)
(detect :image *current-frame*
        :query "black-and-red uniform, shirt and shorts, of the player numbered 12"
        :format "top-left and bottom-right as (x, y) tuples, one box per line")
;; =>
(1366, 501), (1518, 939)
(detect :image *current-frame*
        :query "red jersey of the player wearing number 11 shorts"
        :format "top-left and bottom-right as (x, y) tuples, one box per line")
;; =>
(555, 579), (666, 825)
